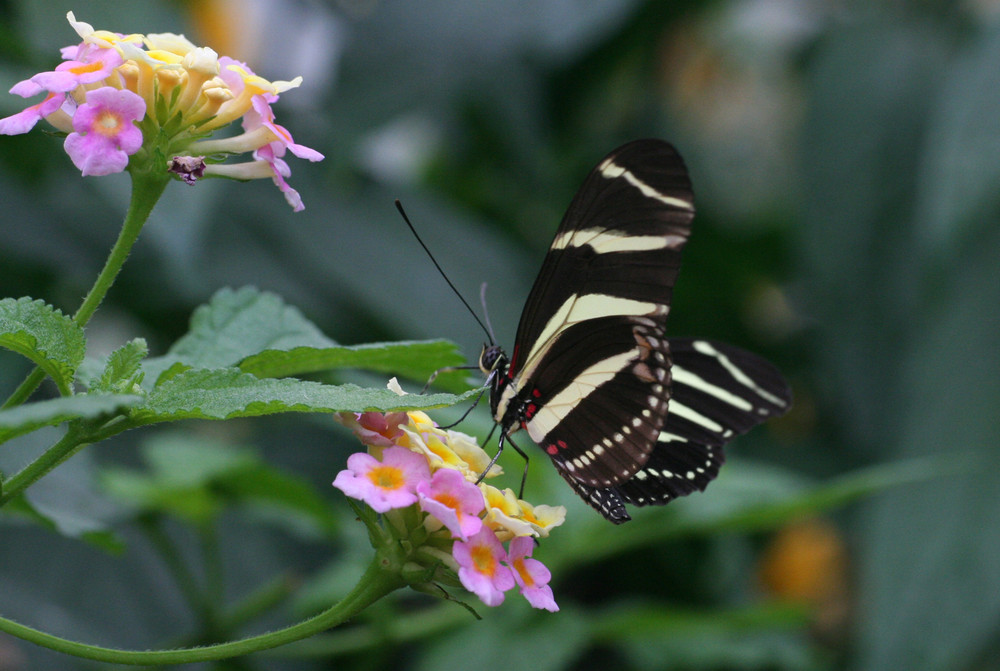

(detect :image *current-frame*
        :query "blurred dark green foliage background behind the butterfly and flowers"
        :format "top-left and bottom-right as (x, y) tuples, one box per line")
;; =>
(0, 0), (1000, 671)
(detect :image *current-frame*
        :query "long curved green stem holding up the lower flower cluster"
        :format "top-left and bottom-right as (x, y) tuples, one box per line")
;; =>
(0, 555), (406, 665)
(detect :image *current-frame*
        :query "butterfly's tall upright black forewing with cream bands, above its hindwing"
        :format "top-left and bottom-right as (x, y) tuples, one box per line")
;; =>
(511, 140), (694, 384)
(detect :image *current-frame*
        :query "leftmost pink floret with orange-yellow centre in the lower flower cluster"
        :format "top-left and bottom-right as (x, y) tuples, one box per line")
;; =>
(333, 447), (431, 513)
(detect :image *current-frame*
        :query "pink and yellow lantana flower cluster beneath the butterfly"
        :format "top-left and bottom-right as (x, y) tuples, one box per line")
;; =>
(333, 404), (566, 611)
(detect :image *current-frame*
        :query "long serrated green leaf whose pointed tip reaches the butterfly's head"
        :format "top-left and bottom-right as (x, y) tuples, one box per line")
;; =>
(131, 368), (478, 424)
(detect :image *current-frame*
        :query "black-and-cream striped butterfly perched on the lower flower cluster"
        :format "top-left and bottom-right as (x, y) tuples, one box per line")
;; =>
(479, 140), (791, 524)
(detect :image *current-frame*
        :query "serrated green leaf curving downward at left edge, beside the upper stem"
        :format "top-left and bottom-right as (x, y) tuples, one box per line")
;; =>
(0, 298), (87, 395)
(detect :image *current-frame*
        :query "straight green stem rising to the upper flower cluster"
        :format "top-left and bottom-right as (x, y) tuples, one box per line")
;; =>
(3, 172), (170, 408)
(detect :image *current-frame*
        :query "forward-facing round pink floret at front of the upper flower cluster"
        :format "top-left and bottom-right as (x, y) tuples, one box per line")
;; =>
(64, 86), (146, 176)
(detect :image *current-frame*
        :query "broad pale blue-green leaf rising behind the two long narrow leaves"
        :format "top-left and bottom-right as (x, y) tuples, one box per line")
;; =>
(143, 287), (337, 383)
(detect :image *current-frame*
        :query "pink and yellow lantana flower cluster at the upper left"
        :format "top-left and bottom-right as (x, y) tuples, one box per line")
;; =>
(0, 12), (323, 211)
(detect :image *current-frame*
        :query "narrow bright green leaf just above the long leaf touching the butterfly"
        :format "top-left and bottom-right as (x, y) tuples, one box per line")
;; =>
(240, 340), (468, 390)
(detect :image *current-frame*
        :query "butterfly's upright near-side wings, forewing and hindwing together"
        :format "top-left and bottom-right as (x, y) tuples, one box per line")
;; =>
(497, 140), (694, 487)
